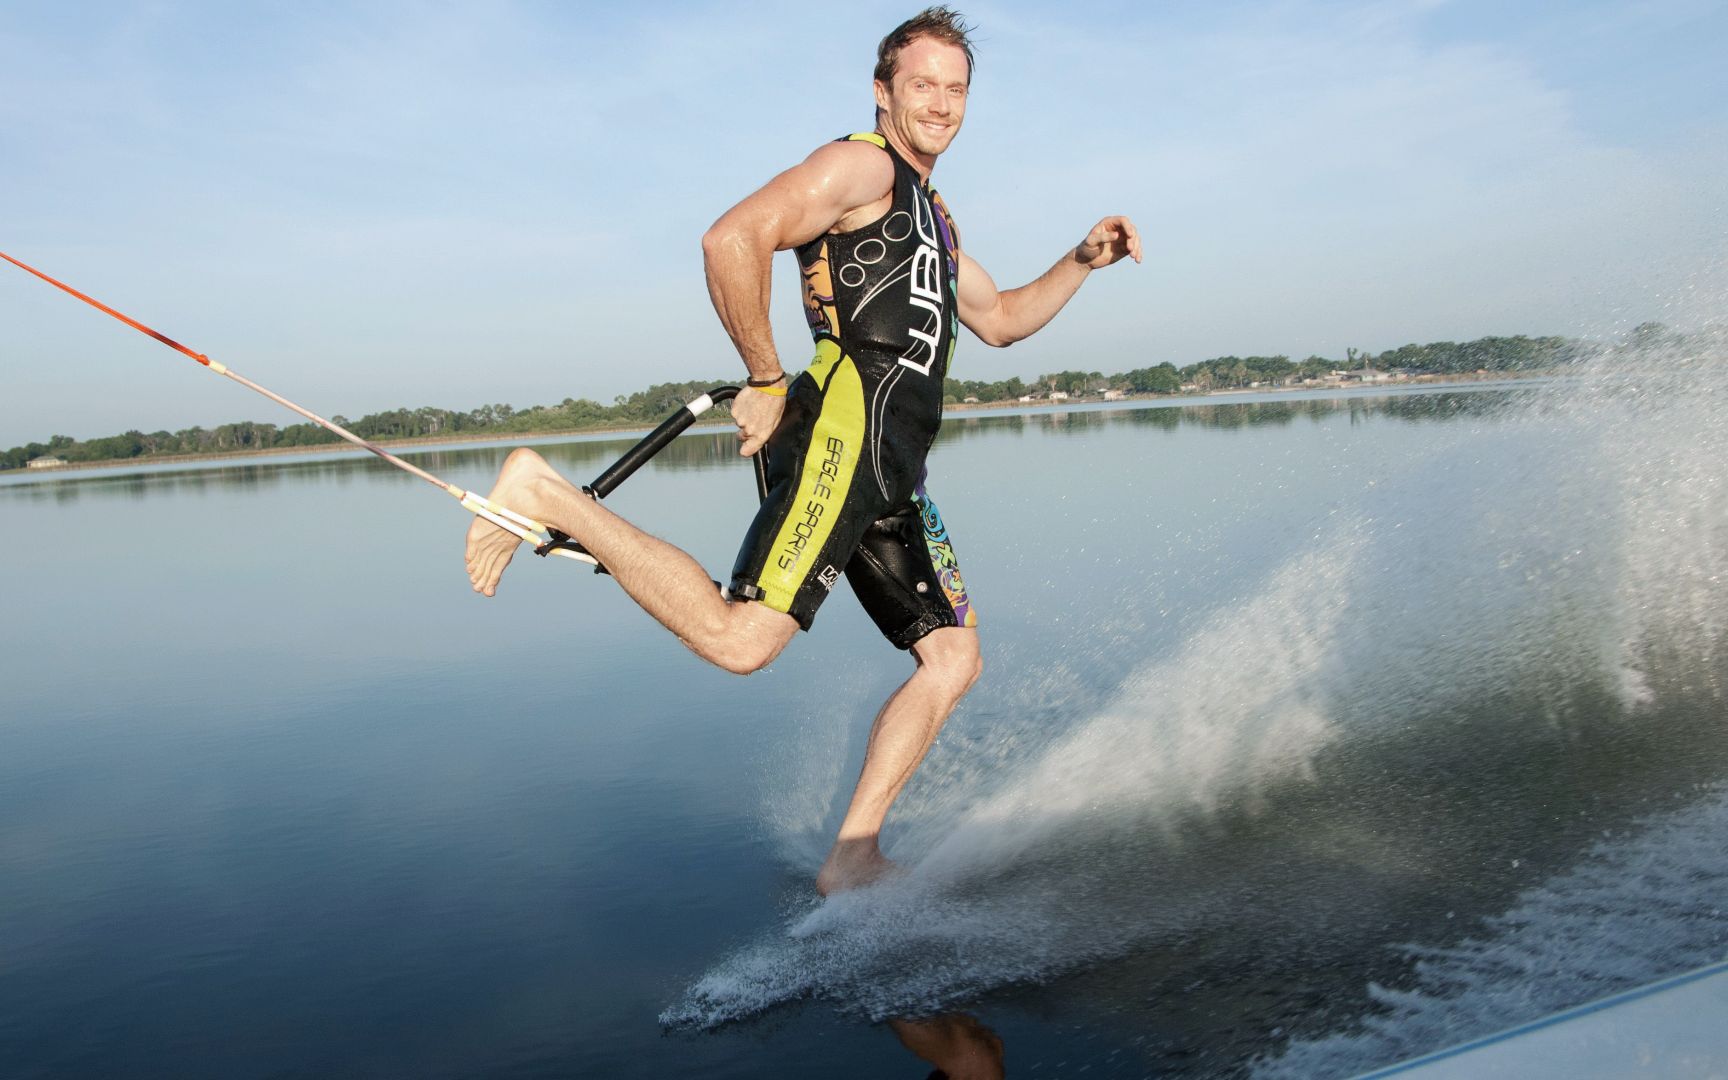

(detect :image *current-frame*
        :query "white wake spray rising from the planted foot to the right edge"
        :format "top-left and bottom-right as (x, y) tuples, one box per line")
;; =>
(662, 328), (1728, 1028)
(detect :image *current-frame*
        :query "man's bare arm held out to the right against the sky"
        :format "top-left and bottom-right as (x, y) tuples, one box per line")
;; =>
(957, 216), (1140, 347)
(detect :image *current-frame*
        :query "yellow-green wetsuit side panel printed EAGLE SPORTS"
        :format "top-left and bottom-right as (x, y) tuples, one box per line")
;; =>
(757, 349), (864, 612)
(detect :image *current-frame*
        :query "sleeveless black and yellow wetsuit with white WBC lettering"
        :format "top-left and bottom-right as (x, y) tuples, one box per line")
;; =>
(731, 135), (976, 648)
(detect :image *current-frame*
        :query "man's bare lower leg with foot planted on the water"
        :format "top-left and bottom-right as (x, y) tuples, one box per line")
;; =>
(816, 627), (983, 897)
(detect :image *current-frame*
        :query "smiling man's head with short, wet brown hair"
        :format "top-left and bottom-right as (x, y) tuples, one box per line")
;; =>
(876, 7), (973, 161)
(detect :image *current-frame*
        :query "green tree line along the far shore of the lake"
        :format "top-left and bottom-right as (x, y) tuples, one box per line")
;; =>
(0, 327), (1589, 468)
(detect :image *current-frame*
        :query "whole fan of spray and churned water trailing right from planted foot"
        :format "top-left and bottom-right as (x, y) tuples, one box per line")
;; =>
(662, 334), (1728, 1028)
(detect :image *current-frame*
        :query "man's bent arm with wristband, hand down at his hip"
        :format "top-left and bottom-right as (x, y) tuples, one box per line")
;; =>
(702, 142), (893, 454)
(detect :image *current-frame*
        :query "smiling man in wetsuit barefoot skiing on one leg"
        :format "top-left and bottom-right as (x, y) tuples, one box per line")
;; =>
(468, 7), (1140, 895)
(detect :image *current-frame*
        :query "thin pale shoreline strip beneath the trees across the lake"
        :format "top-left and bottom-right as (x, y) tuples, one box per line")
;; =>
(0, 372), (1555, 480)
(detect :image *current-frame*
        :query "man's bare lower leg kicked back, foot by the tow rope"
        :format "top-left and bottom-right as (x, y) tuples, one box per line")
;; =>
(467, 449), (798, 674)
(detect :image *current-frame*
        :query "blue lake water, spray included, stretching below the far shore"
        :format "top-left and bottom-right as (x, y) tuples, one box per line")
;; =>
(0, 357), (1728, 1078)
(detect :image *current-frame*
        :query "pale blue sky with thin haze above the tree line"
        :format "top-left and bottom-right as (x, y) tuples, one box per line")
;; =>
(0, 0), (1728, 446)
